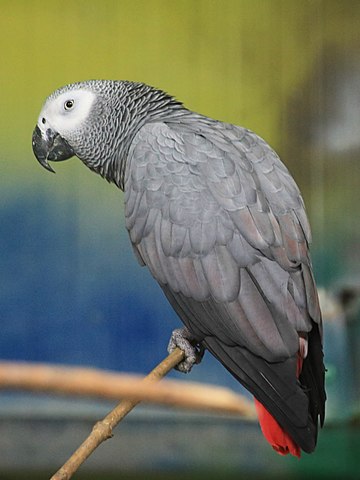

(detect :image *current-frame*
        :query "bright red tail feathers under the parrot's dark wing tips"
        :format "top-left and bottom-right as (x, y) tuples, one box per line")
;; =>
(254, 354), (303, 458)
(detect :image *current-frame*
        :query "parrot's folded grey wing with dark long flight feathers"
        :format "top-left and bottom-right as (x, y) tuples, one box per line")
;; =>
(125, 120), (321, 450)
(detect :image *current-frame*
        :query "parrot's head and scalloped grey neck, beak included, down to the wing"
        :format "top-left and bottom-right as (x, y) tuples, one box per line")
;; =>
(32, 80), (182, 188)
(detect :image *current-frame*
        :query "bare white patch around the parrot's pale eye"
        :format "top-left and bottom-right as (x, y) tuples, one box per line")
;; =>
(38, 90), (95, 135)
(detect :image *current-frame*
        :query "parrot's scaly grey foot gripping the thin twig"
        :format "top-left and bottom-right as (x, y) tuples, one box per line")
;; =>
(168, 327), (205, 373)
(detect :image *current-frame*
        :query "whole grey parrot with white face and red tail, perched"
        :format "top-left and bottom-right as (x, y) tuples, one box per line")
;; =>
(32, 80), (326, 457)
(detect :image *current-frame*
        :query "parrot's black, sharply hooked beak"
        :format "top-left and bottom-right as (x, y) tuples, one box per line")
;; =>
(32, 126), (75, 173)
